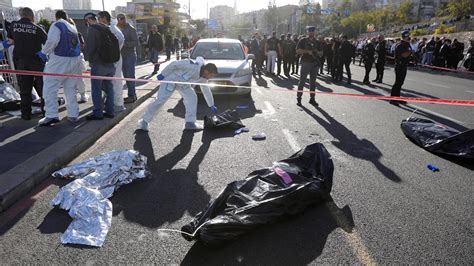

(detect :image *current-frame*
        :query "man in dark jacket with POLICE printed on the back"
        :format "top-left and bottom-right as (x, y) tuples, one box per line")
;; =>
(8, 7), (48, 120)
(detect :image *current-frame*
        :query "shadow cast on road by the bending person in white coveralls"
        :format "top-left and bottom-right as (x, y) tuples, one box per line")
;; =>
(111, 130), (234, 228)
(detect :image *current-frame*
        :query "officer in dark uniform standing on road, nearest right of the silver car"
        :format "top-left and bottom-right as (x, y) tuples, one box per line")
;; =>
(296, 26), (323, 106)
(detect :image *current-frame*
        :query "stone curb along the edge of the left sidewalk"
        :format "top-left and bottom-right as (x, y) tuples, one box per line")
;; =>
(0, 84), (159, 213)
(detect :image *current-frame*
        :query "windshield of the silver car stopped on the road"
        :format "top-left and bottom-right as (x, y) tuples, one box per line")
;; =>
(191, 42), (245, 60)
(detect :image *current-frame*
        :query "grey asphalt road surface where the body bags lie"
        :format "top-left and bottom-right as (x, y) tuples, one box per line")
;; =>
(0, 62), (474, 265)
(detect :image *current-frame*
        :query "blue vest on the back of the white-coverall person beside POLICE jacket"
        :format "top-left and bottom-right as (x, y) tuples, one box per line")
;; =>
(54, 22), (81, 57)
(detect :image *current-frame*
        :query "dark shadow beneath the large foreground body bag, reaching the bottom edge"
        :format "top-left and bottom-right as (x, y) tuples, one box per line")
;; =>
(181, 204), (354, 265)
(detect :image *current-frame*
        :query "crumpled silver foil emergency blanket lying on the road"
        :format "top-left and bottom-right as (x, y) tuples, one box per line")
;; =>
(51, 150), (149, 247)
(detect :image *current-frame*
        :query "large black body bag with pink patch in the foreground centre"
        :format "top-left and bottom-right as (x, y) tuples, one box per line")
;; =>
(181, 143), (334, 245)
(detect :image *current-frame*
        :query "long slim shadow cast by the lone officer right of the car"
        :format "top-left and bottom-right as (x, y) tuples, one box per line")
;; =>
(301, 106), (402, 182)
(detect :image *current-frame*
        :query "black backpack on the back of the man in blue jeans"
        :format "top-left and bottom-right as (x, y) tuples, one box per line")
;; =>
(91, 24), (120, 63)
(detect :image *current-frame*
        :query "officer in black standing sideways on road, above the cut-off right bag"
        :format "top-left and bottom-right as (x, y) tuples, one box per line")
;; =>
(390, 31), (412, 105)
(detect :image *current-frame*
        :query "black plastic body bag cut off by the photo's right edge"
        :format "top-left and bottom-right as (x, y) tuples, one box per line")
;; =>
(401, 117), (474, 159)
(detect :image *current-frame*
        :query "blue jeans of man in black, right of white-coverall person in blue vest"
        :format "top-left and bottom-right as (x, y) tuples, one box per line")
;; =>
(91, 64), (115, 117)
